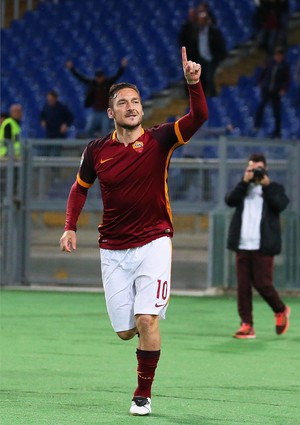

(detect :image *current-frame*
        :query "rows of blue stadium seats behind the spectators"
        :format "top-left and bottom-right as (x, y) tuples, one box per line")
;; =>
(1, 0), (300, 138)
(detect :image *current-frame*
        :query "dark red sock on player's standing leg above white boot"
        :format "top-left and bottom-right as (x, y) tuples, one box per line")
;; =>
(134, 349), (160, 398)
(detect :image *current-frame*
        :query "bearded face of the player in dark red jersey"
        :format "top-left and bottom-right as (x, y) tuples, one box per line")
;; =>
(108, 88), (143, 130)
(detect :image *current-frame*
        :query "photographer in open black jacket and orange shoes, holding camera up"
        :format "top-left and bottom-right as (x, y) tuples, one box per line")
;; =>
(225, 154), (290, 339)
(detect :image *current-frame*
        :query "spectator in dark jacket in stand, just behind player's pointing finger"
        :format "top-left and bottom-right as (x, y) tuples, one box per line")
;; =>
(197, 12), (227, 97)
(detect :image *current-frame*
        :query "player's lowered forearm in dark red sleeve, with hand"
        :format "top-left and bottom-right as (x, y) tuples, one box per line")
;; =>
(60, 181), (88, 252)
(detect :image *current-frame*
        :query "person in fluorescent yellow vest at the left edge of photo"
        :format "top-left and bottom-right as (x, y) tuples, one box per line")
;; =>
(0, 104), (23, 157)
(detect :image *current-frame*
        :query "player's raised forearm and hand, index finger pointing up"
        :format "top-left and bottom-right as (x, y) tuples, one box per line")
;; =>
(178, 47), (208, 142)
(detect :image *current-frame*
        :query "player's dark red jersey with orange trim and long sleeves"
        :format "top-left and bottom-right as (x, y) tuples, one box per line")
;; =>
(65, 80), (207, 249)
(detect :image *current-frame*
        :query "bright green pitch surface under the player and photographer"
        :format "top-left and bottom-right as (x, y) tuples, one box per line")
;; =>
(0, 291), (300, 425)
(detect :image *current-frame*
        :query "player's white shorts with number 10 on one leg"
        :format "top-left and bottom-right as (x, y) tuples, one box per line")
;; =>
(100, 236), (172, 332)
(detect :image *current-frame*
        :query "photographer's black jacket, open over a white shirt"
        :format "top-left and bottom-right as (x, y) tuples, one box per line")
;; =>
(225, 180), (289, 255)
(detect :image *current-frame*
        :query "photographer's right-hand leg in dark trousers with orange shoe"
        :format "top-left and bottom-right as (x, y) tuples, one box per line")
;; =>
(253, 252), (290, 335)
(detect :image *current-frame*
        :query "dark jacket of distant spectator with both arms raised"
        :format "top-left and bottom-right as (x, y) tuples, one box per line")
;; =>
(71, 66), (125, 111)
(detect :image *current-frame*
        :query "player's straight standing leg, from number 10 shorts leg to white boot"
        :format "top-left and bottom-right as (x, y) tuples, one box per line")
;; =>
(130, 238), (172, 415)
